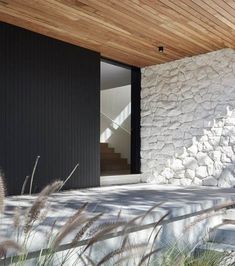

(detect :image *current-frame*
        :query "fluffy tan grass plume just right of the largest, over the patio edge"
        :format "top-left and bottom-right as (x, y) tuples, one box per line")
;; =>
(52, 203), (88, 250)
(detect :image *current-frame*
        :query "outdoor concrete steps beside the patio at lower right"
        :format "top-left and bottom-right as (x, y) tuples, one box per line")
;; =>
(195, 208), (235, 266)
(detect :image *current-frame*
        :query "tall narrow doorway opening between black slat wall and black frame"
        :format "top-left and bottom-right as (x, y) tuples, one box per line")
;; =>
(100, 60), (131, 176)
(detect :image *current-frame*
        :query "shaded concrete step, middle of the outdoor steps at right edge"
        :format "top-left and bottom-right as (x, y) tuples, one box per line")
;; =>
(209, 224), (235, 246)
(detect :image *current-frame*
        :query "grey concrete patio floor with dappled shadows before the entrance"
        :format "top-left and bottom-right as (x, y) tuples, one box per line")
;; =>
(5, 183), (235, 218)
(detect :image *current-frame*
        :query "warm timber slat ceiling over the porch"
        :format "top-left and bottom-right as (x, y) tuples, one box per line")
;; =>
(0, 0), (235, 67)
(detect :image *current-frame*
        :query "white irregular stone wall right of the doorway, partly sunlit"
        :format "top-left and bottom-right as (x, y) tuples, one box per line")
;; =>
(141, 49), (235, 187)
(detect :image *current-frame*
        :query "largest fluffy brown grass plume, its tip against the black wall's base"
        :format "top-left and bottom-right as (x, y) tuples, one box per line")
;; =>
(25, 181), (62, 232)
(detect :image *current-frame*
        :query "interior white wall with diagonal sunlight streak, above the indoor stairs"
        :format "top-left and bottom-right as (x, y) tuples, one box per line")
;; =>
(100, 85), (131, 163)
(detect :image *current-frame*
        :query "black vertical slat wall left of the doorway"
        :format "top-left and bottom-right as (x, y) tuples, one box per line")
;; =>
(0, 23), (100, 194)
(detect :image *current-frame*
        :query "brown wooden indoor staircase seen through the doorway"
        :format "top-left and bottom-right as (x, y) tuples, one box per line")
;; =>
(100, 143), (130, 176)
